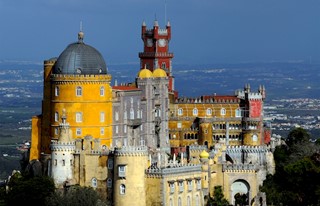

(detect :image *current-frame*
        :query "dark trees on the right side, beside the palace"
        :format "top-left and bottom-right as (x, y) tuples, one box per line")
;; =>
(261, 128), (320, 205)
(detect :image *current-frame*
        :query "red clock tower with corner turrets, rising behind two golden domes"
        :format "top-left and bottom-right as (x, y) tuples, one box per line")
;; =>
(139, 20), (177, 96)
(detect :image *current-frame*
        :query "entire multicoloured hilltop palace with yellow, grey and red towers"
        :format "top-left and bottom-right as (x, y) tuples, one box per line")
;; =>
(29, 21), (274, 206)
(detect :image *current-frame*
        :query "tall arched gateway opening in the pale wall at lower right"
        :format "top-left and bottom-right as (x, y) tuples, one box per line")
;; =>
(231, 180), (250, 206)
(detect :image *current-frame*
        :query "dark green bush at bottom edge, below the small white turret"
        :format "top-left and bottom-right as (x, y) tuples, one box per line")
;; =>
(46, 186), (104, 206)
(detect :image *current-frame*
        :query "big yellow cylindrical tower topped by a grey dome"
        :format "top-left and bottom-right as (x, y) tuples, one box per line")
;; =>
(30, 32), (112, 160)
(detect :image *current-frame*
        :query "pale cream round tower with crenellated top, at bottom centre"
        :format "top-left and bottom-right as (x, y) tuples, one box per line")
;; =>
(113, 147), (148, 206)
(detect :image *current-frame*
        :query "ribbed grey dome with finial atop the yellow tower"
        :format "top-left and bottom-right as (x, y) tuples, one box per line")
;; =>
(53, 33), (107, 74)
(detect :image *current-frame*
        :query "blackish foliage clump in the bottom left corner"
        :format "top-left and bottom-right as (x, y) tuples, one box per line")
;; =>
(6, 173), (55, 206)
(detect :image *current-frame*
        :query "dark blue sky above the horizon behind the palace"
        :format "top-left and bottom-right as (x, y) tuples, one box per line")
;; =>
(0, 0), (320, 65)
